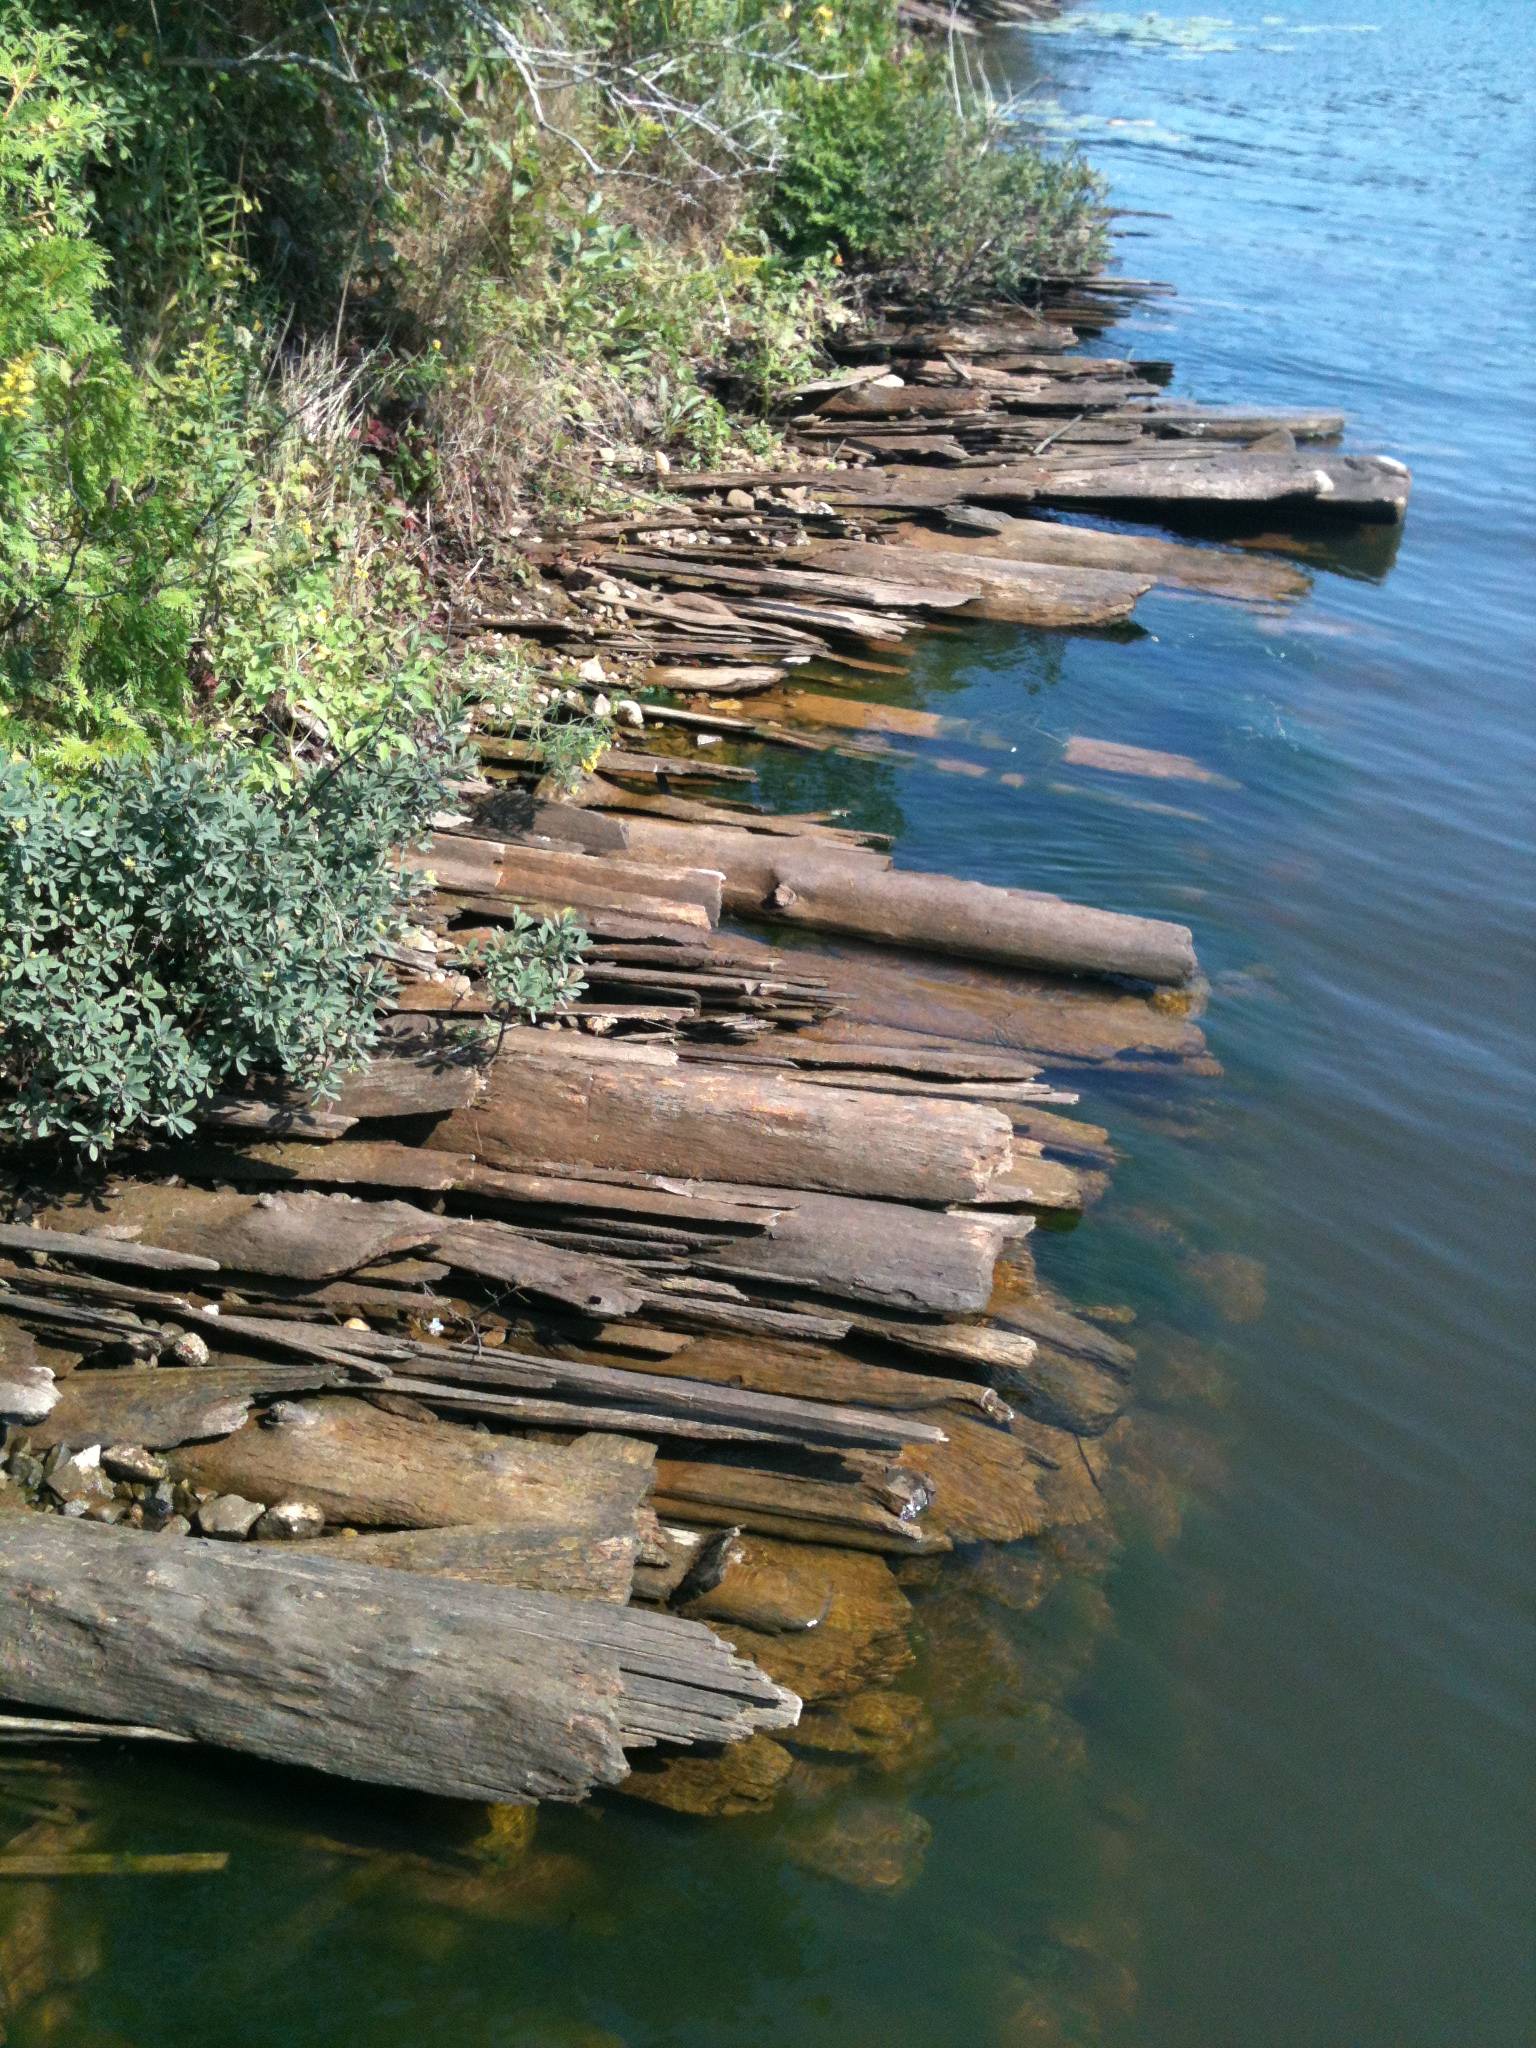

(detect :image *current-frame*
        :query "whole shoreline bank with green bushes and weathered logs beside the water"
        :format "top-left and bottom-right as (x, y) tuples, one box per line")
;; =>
(0, 0), (1409, 1949)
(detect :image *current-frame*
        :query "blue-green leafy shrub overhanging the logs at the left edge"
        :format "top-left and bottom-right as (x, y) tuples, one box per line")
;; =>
(0, 750), (446, 1157)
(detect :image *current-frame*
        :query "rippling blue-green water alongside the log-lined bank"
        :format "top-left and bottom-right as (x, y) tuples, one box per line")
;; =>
(12, 0), (1536, 2048)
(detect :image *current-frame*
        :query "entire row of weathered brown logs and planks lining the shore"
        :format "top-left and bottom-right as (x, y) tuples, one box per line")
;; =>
(0, 283), (1407, 1818)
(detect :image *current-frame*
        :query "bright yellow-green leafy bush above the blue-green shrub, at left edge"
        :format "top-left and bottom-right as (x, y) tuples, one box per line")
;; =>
(0, 25), (450, 770)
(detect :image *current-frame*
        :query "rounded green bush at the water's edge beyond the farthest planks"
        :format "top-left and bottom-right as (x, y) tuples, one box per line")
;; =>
(764, 18), (1102, 305)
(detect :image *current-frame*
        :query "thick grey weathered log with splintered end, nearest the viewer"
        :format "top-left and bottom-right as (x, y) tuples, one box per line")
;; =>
(0, 1516), (799, 1802)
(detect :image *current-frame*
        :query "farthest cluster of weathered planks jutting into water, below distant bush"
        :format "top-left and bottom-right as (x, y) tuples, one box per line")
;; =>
(463, 279), (1409, 679)
